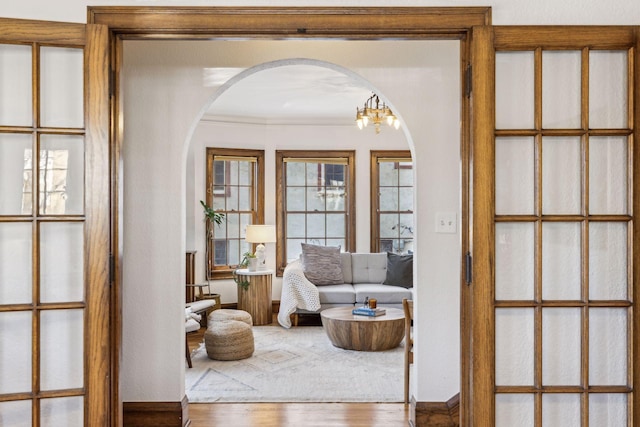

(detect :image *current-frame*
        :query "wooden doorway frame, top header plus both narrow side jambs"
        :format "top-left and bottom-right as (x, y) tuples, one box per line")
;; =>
(87, 6), (491, 425)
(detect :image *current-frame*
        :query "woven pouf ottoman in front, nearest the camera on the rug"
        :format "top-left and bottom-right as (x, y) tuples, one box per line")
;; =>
(204, 320), (254, 360)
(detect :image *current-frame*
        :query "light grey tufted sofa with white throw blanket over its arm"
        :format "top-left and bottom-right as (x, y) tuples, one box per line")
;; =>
(278, 247), (414, 328)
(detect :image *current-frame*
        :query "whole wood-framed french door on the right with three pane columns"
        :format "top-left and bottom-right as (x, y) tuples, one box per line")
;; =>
(465, 27), (640, 427)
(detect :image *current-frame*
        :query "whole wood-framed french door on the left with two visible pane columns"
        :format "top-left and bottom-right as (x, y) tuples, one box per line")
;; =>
(0, 19), (111, 426)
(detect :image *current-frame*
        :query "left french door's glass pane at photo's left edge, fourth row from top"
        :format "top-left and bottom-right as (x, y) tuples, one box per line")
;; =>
(0, 311), (32, 394)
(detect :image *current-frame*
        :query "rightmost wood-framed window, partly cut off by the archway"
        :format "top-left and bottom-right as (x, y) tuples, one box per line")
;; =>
(371, 151), (413, 254)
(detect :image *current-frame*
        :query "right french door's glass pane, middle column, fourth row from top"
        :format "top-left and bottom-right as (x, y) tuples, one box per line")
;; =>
(542, 308), (582, 385)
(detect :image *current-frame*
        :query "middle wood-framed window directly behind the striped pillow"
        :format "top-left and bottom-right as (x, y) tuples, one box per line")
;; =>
(276, 151), (355, 274)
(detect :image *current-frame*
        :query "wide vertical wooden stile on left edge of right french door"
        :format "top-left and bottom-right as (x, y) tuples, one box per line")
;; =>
(463, 27), (495, 427)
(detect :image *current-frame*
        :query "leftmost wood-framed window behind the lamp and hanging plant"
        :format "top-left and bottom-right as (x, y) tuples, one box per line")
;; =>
(205, 148), (264, 279)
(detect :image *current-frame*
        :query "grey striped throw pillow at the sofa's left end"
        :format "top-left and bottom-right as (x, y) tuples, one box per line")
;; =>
(302, 243), (344, 285)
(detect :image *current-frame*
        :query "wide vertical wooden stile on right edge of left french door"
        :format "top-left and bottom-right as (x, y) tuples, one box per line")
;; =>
(85, 25), (112, 426)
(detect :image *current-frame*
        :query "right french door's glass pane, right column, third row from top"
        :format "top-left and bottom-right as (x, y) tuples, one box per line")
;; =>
(589, 222), (628, 300)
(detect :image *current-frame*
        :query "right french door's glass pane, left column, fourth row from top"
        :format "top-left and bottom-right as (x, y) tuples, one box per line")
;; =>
(496, 308), (535, 386)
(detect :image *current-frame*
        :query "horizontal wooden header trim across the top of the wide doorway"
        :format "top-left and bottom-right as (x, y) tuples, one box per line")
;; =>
(88, 6), (491, 39)
